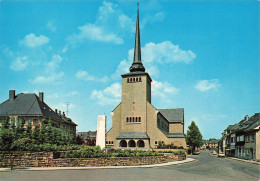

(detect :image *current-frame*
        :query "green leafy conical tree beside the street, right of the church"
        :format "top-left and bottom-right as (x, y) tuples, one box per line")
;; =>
(186, 121), (203, 152)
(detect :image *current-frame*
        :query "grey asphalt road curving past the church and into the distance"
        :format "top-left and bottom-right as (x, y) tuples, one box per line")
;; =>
(0, 151), (260, 181)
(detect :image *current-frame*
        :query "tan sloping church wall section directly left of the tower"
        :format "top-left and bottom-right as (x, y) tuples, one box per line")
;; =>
(106, 103), (121, 148)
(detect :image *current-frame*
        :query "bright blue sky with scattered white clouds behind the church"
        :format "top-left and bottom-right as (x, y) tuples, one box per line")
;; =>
(0, 0), (260, 139)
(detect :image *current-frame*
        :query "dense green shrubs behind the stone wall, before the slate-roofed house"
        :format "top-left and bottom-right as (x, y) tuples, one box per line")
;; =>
(0, 117), (75, 151)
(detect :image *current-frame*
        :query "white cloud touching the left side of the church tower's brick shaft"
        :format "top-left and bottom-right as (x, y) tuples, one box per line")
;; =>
(90, 83), (121, 106)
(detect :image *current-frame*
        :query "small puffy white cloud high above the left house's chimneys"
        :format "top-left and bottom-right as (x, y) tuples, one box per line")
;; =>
(20, 33), (49, 48)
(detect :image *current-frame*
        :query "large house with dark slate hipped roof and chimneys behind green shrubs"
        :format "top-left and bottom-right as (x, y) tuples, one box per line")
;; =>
(0, 90), (77, 136)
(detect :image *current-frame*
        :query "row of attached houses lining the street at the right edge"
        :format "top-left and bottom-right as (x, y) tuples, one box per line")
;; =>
(219, 113), (260, 161)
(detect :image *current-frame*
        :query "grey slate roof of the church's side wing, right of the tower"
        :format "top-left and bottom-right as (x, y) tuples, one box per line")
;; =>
(158, 108), (184, 122)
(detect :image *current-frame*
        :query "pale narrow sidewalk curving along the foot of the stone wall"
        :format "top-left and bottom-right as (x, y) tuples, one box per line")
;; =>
(0, 158), (195, 172)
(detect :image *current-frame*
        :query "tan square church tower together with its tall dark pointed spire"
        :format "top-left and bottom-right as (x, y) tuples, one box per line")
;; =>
(121, 3), (152, 132)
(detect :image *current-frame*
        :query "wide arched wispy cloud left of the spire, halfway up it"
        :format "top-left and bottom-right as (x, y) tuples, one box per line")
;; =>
(68, 24), (124, 44)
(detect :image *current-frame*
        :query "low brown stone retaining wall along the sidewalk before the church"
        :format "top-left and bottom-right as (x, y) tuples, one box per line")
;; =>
(0, 152), (171, 168)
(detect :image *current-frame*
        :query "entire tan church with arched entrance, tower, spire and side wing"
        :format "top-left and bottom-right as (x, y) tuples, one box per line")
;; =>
(106, 4), (186, 149)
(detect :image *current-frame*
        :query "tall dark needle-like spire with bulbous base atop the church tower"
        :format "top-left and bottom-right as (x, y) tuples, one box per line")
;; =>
(129, 3), (145, 72)
